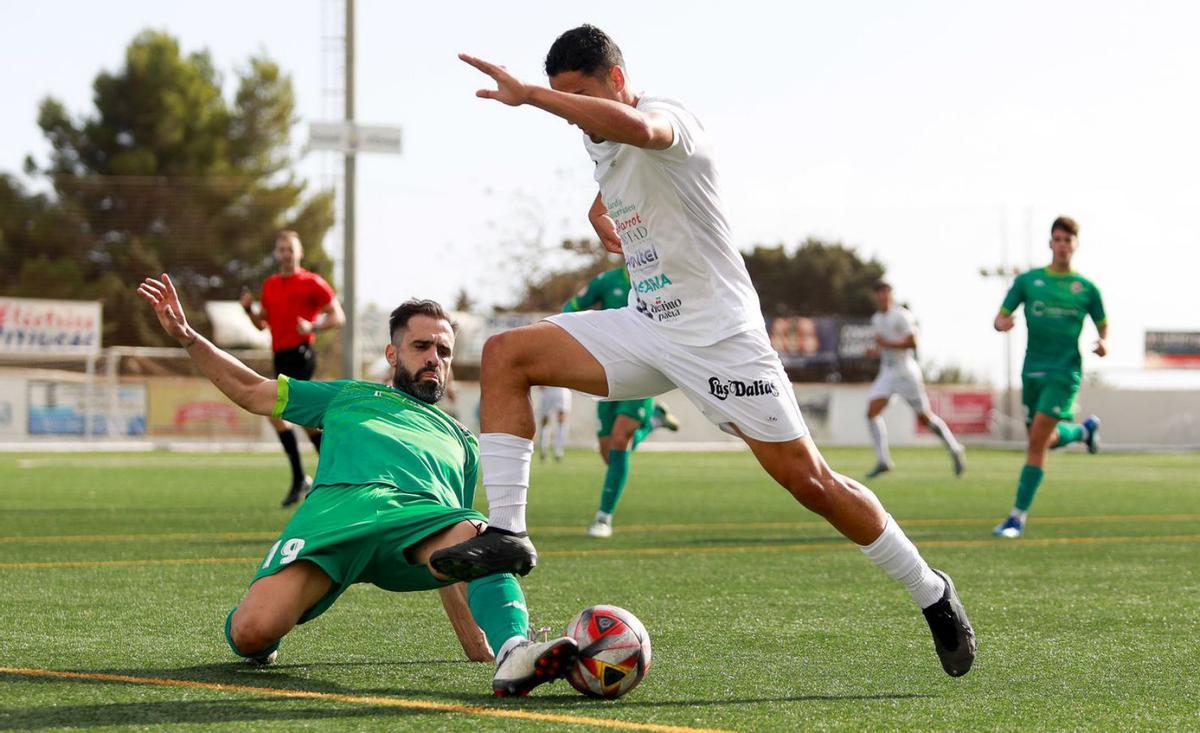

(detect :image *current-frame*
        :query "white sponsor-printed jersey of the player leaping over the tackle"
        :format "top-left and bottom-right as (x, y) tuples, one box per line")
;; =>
(583, 96), (766, 347)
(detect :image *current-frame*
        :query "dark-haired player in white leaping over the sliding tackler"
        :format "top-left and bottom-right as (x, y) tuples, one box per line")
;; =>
(431, 25), (976, 677)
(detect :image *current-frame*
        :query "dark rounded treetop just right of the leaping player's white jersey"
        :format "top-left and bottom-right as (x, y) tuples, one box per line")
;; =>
(744, 238), (883, 318)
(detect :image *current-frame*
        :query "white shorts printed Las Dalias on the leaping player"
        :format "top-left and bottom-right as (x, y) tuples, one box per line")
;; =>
(546, 307), (809, 443)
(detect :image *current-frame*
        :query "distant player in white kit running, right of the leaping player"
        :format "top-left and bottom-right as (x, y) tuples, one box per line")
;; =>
(866, 281), (966, 479)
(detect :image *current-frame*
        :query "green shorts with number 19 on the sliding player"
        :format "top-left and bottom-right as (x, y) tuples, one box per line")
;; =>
(251, 486), (486, 624)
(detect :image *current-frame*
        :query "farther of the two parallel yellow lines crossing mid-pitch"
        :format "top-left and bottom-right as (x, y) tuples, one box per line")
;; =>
(0, 513), (1200, 545)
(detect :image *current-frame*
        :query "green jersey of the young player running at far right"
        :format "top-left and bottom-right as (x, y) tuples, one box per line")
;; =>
(1000, 268), (1105, 379)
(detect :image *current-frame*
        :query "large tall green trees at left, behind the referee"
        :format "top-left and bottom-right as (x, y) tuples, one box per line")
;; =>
(0, 30), (334, 344)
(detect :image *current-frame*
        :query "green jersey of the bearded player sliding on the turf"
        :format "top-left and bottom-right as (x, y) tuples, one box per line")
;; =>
(271, 375), (479, 509)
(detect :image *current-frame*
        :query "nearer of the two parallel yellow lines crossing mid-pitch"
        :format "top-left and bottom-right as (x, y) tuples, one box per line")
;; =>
(7, 535), (1200, 570)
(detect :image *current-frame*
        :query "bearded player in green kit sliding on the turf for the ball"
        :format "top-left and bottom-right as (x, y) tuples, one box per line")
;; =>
(138, 275), (577, 695)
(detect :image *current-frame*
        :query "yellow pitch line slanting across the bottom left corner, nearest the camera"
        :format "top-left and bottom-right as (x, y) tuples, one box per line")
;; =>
(0, 667), (728, 733)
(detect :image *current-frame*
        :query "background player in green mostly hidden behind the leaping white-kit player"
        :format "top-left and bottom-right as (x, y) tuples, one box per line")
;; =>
(563, 268), (679, 539)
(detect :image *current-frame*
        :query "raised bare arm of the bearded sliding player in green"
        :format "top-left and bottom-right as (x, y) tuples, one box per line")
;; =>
(138, 274), (277, 415)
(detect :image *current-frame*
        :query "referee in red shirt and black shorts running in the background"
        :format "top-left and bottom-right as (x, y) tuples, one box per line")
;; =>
(241, 229), (346, 506)
